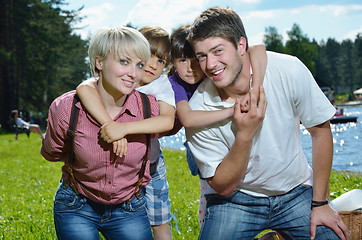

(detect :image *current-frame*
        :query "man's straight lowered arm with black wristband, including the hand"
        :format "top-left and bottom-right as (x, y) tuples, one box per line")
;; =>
(307, 121), (349, 239)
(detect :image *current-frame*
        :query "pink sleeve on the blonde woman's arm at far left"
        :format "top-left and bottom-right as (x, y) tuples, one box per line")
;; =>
(40, 94), (71, 162)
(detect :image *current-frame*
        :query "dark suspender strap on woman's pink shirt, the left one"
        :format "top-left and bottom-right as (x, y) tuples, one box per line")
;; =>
(65, 95), (80, 193)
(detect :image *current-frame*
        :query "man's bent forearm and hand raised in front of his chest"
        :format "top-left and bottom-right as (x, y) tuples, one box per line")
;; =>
(207, 87), (267, 195)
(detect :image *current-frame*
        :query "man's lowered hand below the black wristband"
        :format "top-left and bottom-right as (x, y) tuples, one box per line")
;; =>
(310, 205), (349, 240)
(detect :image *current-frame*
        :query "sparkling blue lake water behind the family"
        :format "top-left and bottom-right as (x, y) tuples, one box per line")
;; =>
(160, 106), (362, 172)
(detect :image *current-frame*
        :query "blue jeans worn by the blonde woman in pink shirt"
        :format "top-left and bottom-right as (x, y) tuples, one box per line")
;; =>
(53, 182), (153, 240)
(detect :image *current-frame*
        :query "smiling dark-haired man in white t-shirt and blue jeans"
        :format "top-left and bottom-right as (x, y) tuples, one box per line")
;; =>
(186, 8), (348, 240)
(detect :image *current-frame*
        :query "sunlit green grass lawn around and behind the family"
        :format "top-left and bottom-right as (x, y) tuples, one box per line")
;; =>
(0, 133), (361, 240)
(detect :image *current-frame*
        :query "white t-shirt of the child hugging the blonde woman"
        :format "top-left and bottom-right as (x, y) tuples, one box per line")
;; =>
(137, 75), (176, 163)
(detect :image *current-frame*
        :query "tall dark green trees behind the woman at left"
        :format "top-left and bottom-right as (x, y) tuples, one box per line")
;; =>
(0, 0), (88, 129)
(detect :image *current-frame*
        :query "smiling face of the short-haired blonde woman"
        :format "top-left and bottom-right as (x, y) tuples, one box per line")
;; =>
(97, 53), (145, 97)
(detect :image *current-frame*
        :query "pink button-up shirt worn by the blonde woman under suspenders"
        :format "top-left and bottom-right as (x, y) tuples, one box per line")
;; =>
(41, 90), (159, 204)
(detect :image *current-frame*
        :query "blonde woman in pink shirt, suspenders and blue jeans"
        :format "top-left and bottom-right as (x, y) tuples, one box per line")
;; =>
(41, 27), (159, 240)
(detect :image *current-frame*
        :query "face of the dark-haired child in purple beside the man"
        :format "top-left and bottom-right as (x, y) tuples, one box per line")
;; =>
(174, 58), (204, 84)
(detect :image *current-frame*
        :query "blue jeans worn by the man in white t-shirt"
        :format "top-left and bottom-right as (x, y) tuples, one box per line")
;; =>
(199, 185), (339, 240)
